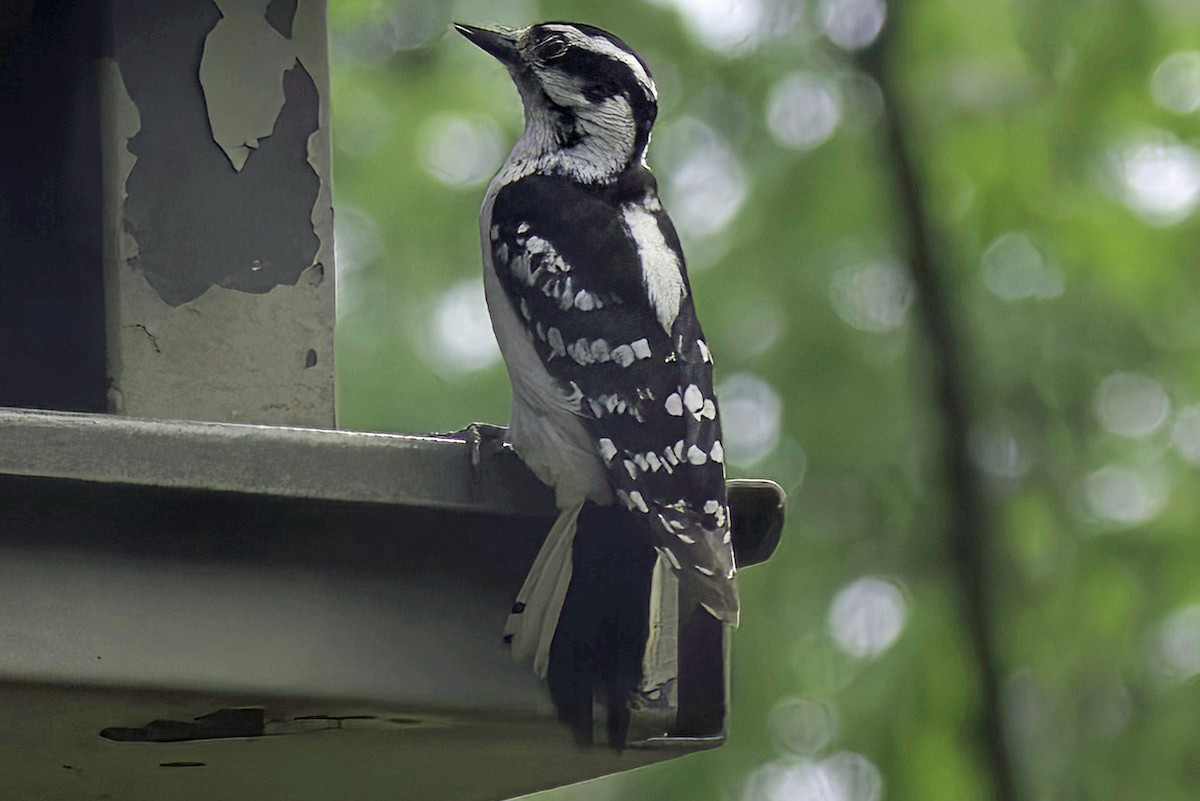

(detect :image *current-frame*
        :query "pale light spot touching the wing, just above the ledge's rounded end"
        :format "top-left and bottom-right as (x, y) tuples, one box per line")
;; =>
(716, 373), (784, 466)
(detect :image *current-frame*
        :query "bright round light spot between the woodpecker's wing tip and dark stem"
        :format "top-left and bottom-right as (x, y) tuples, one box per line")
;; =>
(829, 576), (908, 660)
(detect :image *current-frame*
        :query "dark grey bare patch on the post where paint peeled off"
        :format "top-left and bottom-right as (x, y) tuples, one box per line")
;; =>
(118, 6), (328, 306)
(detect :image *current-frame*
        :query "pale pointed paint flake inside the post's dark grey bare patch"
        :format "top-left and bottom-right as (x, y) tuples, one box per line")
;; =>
(200, 0), (296, 171)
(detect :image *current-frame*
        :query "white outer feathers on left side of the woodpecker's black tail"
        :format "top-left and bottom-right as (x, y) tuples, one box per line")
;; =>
(504, 502), (583, 679)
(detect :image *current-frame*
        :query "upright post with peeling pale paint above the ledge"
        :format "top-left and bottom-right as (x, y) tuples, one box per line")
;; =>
(101, 0), (335, 427)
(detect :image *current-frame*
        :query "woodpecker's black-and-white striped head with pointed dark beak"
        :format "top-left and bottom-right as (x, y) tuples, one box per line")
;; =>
(455, 23), (659, 176)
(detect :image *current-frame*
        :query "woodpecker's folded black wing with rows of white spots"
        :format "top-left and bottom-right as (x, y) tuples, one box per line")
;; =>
(488, 176), (737, 622)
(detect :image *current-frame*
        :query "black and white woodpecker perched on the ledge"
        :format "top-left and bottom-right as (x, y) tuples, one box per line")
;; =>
(456, 23), (738, 714)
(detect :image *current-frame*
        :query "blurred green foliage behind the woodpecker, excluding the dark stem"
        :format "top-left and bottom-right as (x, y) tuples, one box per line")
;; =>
(330, 0), (1200, 801)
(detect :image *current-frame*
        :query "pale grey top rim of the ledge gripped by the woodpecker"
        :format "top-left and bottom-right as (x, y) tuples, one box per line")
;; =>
(0, 408), (785, 566)
